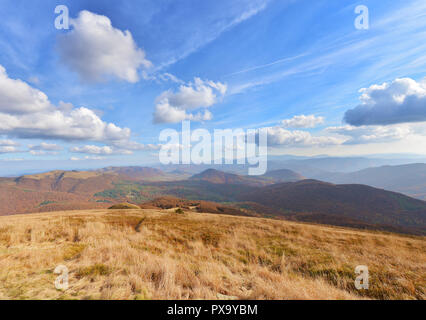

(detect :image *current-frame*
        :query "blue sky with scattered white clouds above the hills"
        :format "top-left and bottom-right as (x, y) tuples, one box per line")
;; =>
(0, 0), (426, 174)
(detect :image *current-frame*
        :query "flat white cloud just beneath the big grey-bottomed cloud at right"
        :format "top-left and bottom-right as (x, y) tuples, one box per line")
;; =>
(326, 125), (414, 145)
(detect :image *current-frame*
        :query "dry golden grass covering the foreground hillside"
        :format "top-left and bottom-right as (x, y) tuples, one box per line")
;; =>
(0, 210), (426, 299)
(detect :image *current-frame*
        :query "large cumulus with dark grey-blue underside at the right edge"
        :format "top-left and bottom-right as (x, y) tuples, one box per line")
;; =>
(344, 78), (426, 126)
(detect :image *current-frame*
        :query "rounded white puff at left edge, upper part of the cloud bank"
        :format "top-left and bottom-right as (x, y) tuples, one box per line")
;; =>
(0, 65), (50, 114)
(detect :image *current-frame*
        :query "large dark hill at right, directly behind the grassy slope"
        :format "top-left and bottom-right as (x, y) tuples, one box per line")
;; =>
(240, 180), (426, 234)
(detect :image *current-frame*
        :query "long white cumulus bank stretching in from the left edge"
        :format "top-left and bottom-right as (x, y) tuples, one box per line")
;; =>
(0, 66), (130, 141)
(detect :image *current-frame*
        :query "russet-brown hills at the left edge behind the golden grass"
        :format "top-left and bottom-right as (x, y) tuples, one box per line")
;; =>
(0, 167), (171, 215)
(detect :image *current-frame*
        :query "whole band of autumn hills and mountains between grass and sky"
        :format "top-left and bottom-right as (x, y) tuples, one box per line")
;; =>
(0, 165), (426, 234)
